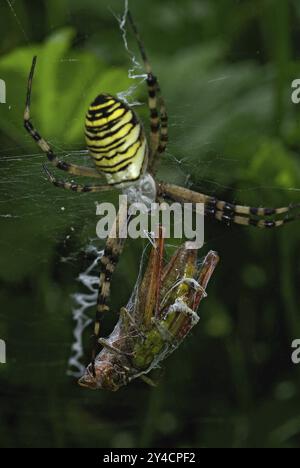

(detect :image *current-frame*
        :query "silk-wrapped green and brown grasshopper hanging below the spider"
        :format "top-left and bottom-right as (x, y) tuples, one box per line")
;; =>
(79, 230), (219, 391)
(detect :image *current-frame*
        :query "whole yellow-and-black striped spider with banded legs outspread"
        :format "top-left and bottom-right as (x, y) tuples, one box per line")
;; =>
(24, 12), (298, 376)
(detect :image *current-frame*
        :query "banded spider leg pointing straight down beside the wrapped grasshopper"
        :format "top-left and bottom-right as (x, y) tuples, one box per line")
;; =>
(92, 204), (128, 375)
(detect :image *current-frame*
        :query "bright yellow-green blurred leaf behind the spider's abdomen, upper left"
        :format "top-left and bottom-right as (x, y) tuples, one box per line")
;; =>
(0, 28), (130, 145)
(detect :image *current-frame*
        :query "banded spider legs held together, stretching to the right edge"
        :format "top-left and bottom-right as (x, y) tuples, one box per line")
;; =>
(157, 183), (300, 228)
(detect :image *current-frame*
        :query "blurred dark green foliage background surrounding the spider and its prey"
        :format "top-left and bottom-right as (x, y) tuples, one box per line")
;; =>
(0, 0), (300, 448)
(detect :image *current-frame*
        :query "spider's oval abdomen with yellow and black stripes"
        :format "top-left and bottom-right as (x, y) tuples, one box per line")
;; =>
(85, 94), (147, 184)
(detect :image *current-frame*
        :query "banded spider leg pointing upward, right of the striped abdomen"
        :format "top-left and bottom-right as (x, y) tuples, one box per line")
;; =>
(128, 12), (168, 172)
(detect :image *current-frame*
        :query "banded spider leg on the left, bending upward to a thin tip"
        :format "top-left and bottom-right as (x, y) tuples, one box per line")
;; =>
(24, 56), (102, 178)
